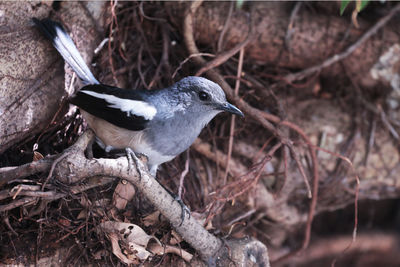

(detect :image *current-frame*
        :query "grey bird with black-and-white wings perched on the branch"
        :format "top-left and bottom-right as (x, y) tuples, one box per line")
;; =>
(32, 18), (244, 176)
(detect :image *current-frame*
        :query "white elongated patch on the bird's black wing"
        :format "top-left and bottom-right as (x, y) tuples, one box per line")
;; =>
(81, 90), (157, 120)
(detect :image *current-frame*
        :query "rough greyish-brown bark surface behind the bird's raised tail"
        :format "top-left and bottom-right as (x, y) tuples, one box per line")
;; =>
(0, 2), (104, 153)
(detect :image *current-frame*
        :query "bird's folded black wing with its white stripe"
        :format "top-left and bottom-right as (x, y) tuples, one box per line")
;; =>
(70, 84), (156, 131)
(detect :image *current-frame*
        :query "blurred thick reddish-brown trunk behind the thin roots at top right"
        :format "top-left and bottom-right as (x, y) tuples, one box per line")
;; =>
(168, 2), (400, 88)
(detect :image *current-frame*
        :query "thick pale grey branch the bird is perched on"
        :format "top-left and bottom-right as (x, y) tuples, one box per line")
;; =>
(48, 132), (222, 260)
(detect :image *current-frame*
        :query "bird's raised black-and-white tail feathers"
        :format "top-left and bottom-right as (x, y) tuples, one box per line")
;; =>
(32, 18), (99, 84)
